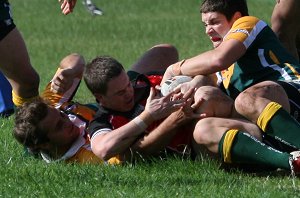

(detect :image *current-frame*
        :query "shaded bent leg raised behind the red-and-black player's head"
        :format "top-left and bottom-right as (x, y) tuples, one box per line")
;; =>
(129, 44), (178, 74)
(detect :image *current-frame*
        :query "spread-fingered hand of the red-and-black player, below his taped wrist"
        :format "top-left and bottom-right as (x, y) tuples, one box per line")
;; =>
(145, 88), (186, 120)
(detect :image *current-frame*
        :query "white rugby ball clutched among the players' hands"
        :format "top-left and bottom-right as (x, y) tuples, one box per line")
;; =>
(160, 75), (193, 96)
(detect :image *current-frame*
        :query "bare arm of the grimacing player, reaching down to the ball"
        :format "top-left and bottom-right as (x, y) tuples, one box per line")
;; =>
(163, 39), (246, 82)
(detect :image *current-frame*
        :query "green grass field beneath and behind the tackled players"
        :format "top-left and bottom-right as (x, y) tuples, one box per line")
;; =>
(0, 0), (300, 198)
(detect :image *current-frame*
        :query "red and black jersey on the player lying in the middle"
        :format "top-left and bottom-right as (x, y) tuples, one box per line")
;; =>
(88, 74), (192, 153)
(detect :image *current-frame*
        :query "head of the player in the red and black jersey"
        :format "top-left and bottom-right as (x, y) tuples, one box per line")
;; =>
(84, 56), (134, 112)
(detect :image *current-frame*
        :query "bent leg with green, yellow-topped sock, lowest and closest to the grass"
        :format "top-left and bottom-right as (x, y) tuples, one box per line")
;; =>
(194, 118), (291, 170)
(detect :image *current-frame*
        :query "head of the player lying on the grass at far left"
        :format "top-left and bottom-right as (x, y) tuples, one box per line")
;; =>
(13, 99), (80, 154)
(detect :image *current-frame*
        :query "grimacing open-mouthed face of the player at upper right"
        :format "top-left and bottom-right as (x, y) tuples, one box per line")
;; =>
(202, 12), (234, 48)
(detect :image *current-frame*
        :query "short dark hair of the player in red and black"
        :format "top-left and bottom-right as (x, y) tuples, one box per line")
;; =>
(83, 56), (124, 94)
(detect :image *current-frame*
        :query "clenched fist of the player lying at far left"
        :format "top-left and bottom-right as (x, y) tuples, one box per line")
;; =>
(51, 69), (74, 93)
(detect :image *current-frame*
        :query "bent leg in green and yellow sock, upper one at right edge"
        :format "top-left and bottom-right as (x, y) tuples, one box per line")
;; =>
(235, 81), (300, 150)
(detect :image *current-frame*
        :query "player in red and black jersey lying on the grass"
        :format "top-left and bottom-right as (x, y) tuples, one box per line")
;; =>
(84, 44), (203, 160)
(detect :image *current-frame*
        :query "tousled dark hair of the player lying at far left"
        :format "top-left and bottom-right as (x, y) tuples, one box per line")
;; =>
(13, 98), (49, 148)
